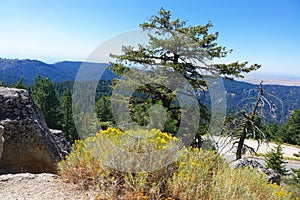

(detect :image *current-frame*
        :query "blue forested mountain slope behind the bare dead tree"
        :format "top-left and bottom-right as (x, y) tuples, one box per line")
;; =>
(224, 80), (300, 123)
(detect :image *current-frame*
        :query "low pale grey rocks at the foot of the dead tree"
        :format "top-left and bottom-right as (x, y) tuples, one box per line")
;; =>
(231, 158), (281, 185)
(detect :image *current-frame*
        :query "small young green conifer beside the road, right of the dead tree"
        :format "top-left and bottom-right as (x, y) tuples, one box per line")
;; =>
(265, 145), (287, 176)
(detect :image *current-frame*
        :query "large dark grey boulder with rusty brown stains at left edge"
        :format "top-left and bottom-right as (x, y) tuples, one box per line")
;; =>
(0, 87), (70, 174)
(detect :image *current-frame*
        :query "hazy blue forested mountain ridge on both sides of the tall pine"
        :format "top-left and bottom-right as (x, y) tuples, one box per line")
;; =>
(0, 58), (300, 123)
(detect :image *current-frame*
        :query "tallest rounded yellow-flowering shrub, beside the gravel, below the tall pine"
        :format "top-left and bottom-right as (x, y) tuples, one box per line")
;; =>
(59, 128), (178, 197)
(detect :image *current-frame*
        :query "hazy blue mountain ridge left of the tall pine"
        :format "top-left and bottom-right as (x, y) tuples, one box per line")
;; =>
(0, 58), (116, 85)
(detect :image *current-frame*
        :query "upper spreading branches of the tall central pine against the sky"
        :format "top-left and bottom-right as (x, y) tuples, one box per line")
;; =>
(112, 8), (260, 81)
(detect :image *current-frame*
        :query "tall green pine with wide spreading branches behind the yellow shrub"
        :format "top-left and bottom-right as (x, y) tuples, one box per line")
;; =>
(111, 8), (260, 146)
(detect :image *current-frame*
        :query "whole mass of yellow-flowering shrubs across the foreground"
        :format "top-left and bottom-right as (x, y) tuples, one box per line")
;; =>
(59, 128), (290, 200)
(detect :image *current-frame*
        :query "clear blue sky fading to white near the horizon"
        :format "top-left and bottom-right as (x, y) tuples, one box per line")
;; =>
(0, 0), (300, 77)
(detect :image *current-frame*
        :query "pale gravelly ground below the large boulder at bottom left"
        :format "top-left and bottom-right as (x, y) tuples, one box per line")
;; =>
(0, 173), (95, 200)
